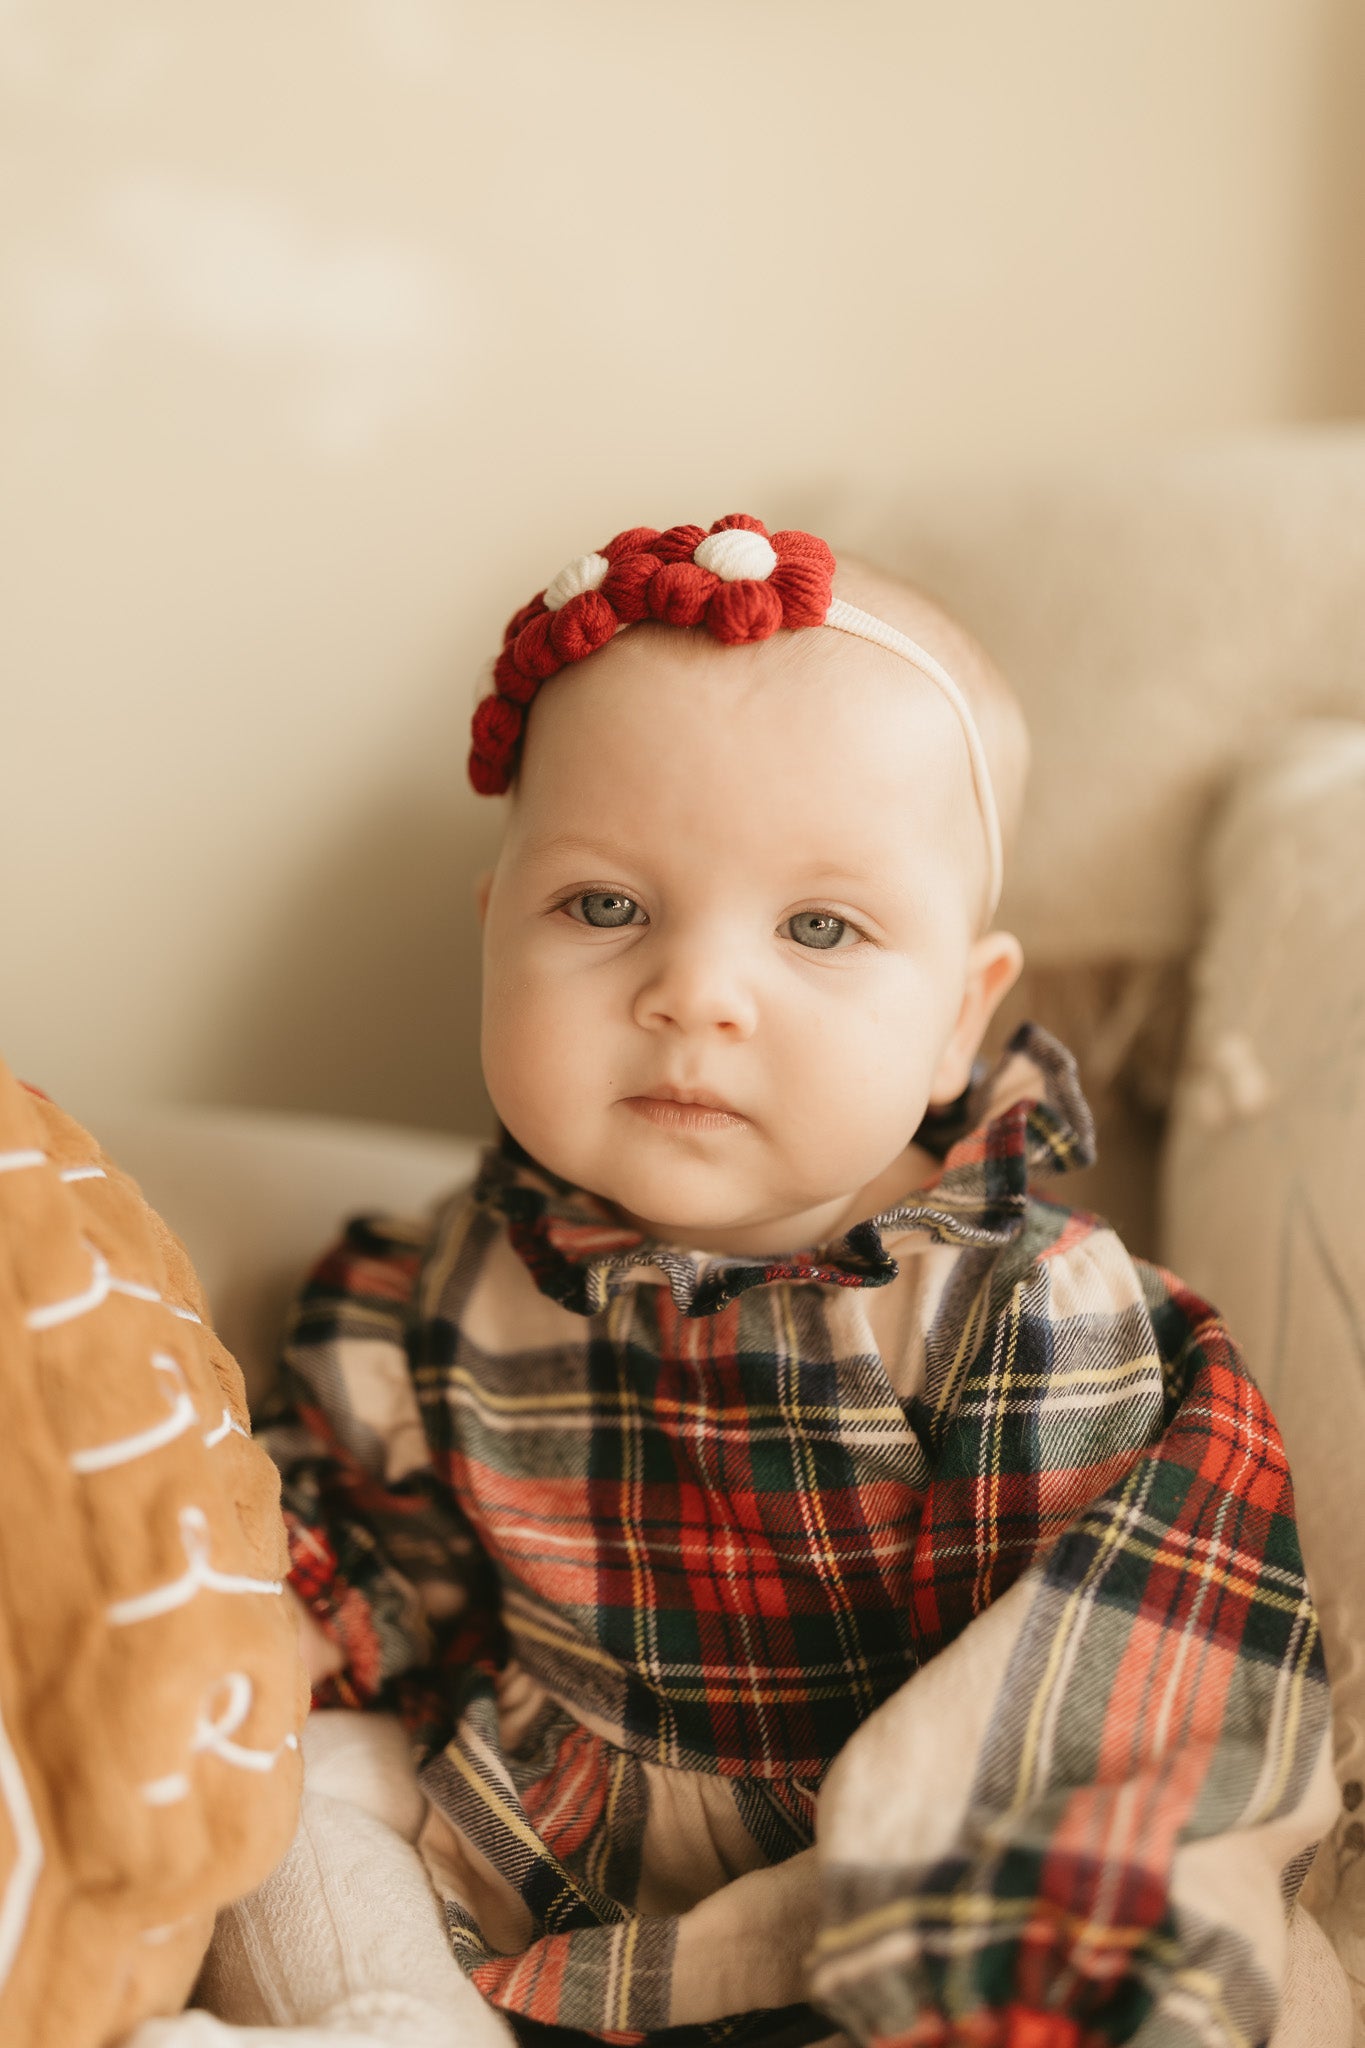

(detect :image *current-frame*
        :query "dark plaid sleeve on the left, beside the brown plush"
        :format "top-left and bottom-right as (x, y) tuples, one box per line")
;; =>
(264, 1217), (497, 1743)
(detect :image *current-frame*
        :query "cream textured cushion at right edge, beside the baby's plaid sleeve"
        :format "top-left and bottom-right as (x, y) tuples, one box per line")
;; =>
(1162, 721), (1365, 2034)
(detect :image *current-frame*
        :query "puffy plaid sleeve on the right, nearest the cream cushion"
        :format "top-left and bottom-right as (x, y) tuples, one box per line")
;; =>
(812, 1219), (1336, 2048)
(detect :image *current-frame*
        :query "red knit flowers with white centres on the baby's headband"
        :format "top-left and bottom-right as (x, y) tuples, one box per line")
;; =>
(469, 512), (835, 797)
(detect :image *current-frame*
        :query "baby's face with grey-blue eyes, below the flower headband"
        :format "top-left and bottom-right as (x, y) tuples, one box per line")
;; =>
(483, 627), (1017, 1251)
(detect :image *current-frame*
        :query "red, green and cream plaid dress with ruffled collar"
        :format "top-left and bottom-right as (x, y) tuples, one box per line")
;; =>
(268, 1026), (1334, 2048)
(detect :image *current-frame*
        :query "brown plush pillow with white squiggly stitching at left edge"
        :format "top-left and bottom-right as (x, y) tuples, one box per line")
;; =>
(0, 1063), (307, 2048)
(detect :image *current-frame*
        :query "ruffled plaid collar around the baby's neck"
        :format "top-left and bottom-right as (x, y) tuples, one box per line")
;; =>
(473, 1024), (1095, 1315)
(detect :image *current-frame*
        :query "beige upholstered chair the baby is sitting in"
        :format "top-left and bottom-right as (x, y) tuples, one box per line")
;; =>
(93, 430), (1365, 2042)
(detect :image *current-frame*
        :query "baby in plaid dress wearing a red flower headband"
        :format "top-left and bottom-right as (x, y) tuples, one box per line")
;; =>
(255, 518), (1334, 2048)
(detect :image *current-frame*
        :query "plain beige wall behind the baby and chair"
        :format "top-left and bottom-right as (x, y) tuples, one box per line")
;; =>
(0, 0), (1365, 1128)
